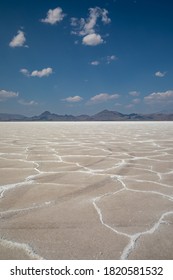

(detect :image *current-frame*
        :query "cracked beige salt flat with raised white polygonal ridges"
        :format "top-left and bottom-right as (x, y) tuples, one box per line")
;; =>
(0, 122), (173, 259)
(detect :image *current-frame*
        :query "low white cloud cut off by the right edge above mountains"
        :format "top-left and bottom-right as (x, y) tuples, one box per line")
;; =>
(144, 90), (173, 104)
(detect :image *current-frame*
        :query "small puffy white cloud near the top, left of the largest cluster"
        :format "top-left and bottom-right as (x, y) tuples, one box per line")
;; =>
(41, 7), (65, 25)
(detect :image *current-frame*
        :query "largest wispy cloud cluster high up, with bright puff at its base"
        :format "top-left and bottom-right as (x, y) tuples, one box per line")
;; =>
(71, 7), (111, 46)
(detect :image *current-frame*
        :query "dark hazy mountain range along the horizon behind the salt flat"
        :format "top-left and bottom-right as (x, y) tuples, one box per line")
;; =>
(0, 110), (173, 121)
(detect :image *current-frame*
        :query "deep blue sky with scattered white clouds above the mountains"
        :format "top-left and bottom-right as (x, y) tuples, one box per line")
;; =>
(0, 0), (173, 116)
